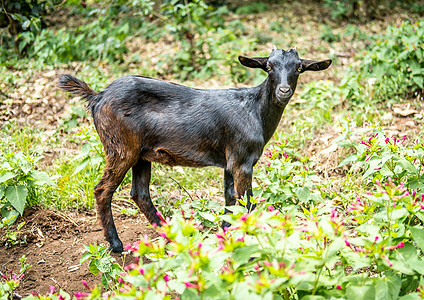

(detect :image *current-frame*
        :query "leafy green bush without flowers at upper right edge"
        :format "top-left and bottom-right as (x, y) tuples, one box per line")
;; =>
(341, 20), (424, 103)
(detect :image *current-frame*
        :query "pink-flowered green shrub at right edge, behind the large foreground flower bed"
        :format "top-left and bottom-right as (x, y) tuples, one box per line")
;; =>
(334, 120), (424, 192)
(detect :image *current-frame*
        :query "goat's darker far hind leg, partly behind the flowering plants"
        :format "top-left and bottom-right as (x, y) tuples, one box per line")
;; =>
(131, 159), (161, 225)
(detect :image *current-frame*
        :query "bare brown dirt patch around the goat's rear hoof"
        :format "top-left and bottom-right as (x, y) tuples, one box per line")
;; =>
(0, 208), (156, 299)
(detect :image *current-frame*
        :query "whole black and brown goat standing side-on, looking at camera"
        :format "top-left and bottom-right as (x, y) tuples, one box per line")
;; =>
(59, 49), (331, 252)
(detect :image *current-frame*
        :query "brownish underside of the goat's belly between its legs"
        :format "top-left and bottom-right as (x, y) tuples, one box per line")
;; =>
(141, 147), (226, 168)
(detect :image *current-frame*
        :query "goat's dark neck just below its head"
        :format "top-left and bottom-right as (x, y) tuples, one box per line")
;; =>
(255, 78), (285, 143)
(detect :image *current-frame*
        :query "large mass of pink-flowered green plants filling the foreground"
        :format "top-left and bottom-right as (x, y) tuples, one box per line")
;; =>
(35, 182), (424, 299)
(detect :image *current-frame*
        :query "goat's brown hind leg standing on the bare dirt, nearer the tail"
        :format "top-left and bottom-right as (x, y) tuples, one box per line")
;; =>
(94, 158), (132, 253)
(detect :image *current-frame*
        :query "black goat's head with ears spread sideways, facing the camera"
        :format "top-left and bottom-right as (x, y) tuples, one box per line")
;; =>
(239, 49), (331, 107)
